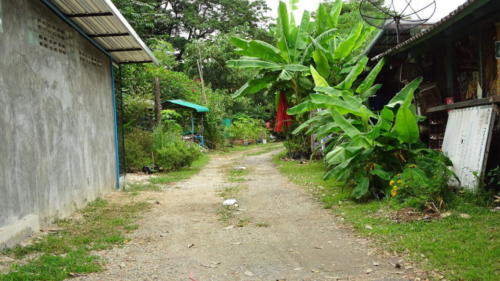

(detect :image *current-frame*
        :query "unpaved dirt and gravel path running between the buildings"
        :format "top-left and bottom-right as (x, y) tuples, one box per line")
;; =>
(78, 148), (413, 281)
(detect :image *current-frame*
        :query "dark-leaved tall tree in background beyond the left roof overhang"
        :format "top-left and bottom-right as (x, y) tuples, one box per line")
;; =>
(113, 0), (269, 59)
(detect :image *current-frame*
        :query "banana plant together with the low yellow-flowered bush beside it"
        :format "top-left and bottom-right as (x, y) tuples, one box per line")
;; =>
(289, 62), (452, 208)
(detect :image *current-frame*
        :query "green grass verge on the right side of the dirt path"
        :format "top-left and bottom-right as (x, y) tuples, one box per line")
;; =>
(274, 153), (500, 281)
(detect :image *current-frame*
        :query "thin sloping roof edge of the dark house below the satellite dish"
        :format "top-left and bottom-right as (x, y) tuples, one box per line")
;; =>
(372, 0), (490, 60)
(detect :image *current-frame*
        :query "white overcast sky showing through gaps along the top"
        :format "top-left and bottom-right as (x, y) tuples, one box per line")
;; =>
(266, 0), (466, 22)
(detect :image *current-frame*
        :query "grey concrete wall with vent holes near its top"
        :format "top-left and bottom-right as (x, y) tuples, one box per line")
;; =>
(0, 0), (116, 245)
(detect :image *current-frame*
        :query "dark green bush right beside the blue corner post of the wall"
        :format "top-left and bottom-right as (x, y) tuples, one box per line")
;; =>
(125, 128), (153, 172)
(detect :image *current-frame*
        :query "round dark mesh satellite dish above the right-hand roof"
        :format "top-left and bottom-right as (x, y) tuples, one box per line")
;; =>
(359, 0), (436, 44)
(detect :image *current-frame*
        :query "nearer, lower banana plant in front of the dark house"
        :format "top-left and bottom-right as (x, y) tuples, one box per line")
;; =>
(289, 61), (423, 199)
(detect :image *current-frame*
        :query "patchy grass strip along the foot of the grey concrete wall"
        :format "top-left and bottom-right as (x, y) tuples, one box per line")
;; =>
(0, 199), (149, 281)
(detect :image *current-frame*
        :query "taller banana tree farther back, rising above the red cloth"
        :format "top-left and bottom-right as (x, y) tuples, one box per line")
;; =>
(228, 0), (373, 155)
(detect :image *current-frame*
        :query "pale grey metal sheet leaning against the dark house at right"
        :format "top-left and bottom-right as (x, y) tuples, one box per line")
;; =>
(443, 105), (496, 190)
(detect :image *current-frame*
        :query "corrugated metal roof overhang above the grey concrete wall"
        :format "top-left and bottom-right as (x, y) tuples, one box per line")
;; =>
(50, 0), (158, 63)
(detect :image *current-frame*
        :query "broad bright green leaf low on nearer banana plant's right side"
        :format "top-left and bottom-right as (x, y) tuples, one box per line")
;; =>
(393, 106), (419, 143)
